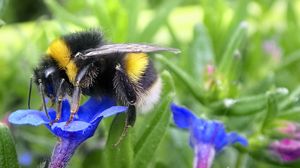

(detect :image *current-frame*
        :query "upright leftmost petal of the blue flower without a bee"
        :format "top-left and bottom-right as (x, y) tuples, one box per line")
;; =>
(171, 103), (196, 129)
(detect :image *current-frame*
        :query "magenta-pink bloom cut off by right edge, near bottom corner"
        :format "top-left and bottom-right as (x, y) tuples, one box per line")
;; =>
(271, 139), (300, 162)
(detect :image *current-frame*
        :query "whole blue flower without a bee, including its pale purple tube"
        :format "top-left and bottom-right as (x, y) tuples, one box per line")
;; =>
(171, 104), (248, 168)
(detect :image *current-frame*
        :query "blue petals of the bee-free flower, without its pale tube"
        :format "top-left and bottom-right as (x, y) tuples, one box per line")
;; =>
(171, 104), (248, 152)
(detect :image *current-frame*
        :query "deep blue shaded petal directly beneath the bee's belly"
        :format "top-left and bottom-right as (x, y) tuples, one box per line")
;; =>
(78, 96), (116, 122)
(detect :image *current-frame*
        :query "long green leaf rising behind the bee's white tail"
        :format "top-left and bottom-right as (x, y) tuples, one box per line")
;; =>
(133, 71), (174, 168)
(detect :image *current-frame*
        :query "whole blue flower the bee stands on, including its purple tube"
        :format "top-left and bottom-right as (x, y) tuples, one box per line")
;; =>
(8, 97), (127, 168)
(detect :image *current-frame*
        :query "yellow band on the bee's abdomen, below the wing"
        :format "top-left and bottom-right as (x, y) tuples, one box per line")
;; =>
(124, 53), (149, 82)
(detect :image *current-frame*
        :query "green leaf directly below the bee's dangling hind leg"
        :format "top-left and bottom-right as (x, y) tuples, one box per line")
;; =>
(105, 113), (133, 168)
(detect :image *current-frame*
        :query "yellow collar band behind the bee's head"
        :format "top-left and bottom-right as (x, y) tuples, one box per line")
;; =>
(47, 39), (78, 83)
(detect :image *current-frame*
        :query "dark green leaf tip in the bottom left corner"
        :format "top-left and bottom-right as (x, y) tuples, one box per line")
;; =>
(0, 123), (19, 168)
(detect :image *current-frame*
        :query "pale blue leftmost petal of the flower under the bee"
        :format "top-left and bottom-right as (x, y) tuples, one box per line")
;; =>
(8, 110), (49, 126)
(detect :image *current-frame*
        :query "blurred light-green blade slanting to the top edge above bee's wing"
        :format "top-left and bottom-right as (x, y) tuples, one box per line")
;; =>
(138, 0), (181, 41)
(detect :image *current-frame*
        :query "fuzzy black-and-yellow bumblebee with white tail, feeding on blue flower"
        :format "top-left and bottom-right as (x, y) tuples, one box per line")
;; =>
(28, 30), (179, 130)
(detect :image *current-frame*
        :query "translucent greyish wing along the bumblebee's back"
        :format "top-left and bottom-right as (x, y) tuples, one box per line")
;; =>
(81, 43), (180, 58)
